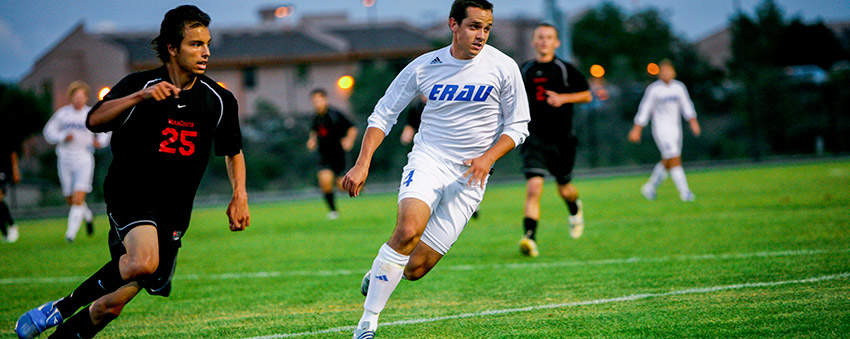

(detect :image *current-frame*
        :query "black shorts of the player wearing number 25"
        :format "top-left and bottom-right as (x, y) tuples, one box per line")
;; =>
(107, 208), (186, 297)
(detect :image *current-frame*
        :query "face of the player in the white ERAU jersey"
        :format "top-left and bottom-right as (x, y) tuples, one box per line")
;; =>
(449, 7), (493, 60)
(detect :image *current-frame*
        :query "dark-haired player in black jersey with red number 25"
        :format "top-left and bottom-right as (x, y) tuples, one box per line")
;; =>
(16, 6), (250, 338)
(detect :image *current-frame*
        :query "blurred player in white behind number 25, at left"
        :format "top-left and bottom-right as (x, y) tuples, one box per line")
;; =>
(44, 81), (109, 243)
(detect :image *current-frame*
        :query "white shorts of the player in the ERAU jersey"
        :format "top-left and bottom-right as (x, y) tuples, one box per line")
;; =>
(398, 149), (489, 255)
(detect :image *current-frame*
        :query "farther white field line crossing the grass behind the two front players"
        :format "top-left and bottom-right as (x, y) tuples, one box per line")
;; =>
(0, 249), (850, 285)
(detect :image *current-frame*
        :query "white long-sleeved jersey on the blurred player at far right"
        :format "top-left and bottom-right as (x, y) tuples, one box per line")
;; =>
(635, 79), (697, 135)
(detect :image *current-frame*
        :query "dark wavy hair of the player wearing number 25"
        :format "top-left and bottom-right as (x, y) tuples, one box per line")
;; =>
(151, 5), (210, 63)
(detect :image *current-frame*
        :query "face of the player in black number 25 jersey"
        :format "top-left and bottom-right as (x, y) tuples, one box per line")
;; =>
(168, 26), (211, 75)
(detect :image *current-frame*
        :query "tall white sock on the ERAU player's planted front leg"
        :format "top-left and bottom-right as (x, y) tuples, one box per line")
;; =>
(358, 244), (410, 331)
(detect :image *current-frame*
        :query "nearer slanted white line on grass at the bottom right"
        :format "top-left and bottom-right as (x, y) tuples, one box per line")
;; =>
(240, 272), (850, 339)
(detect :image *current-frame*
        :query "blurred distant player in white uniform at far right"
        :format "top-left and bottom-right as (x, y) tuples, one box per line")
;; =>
(629, 60), (700, 201)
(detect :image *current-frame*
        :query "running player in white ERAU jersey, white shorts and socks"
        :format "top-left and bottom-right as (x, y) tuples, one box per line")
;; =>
(342, 0), (529, 339)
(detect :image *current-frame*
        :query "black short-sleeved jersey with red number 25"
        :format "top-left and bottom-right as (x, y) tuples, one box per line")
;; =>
(89, 66), (242, 227)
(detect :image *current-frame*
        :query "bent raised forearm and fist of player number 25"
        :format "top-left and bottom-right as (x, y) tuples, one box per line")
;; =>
(86, 81), (180, 132)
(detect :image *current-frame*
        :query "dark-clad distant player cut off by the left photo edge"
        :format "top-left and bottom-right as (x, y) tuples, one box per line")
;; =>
(0, 132), (21, 243)
